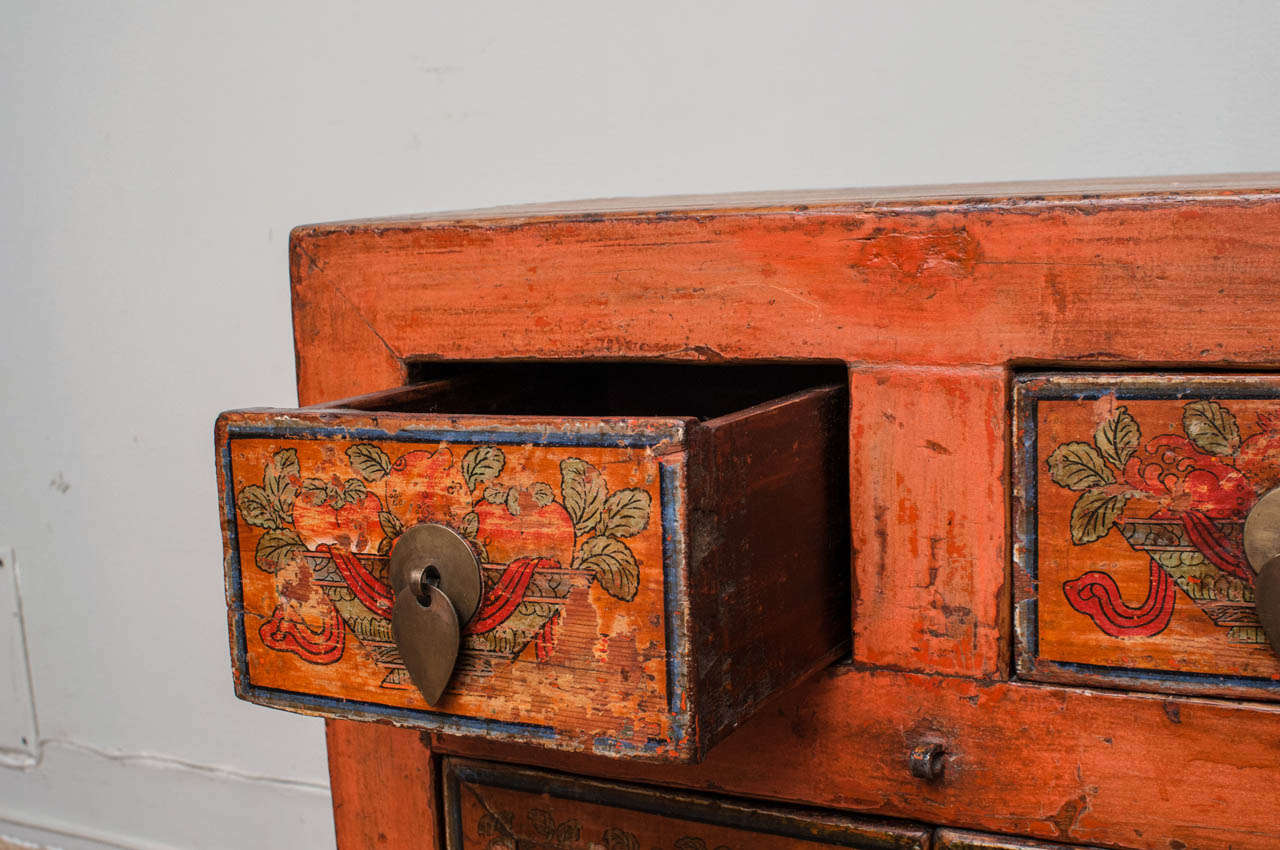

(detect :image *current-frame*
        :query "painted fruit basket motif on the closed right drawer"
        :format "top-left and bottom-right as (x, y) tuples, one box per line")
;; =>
(1047, 401), (1280, 643)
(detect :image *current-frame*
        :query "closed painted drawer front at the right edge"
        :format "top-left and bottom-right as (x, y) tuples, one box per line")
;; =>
(1015, 375), (1280, 699)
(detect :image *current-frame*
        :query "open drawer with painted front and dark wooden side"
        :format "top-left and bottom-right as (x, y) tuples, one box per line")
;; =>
(215, 365), (850, 760)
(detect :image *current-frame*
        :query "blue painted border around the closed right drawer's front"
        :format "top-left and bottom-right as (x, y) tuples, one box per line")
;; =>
(1014, 374), (1280, 693)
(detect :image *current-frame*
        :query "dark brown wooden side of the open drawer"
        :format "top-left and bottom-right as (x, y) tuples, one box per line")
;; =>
(689, 387), (850, 745)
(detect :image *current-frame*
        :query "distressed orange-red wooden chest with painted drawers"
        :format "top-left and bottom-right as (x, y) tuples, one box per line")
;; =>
(218, 177), (1280, 850)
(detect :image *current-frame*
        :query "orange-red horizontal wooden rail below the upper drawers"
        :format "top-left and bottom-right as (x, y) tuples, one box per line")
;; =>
(434, 667), (1280, 850)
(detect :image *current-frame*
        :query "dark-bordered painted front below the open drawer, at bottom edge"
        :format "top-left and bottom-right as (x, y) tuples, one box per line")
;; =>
(444, 759), (929, 850)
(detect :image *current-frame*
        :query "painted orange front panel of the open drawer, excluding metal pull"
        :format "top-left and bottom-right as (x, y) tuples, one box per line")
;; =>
(220, 412), (685, 753)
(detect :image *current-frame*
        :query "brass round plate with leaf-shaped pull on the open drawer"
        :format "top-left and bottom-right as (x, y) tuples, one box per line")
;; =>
(389, 522), (484, 705)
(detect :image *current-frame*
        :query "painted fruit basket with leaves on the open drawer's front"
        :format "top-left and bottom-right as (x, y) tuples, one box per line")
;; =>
(236, 443), (652, 687)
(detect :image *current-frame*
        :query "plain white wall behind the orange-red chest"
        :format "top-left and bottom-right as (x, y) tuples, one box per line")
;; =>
(0, 0), (1280, 849)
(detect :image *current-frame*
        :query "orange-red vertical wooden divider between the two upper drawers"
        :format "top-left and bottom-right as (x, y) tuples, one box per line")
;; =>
(849, 366), (1009, 678)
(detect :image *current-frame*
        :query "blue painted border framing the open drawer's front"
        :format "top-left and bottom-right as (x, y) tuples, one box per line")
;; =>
(220, 425), (691, 753)
